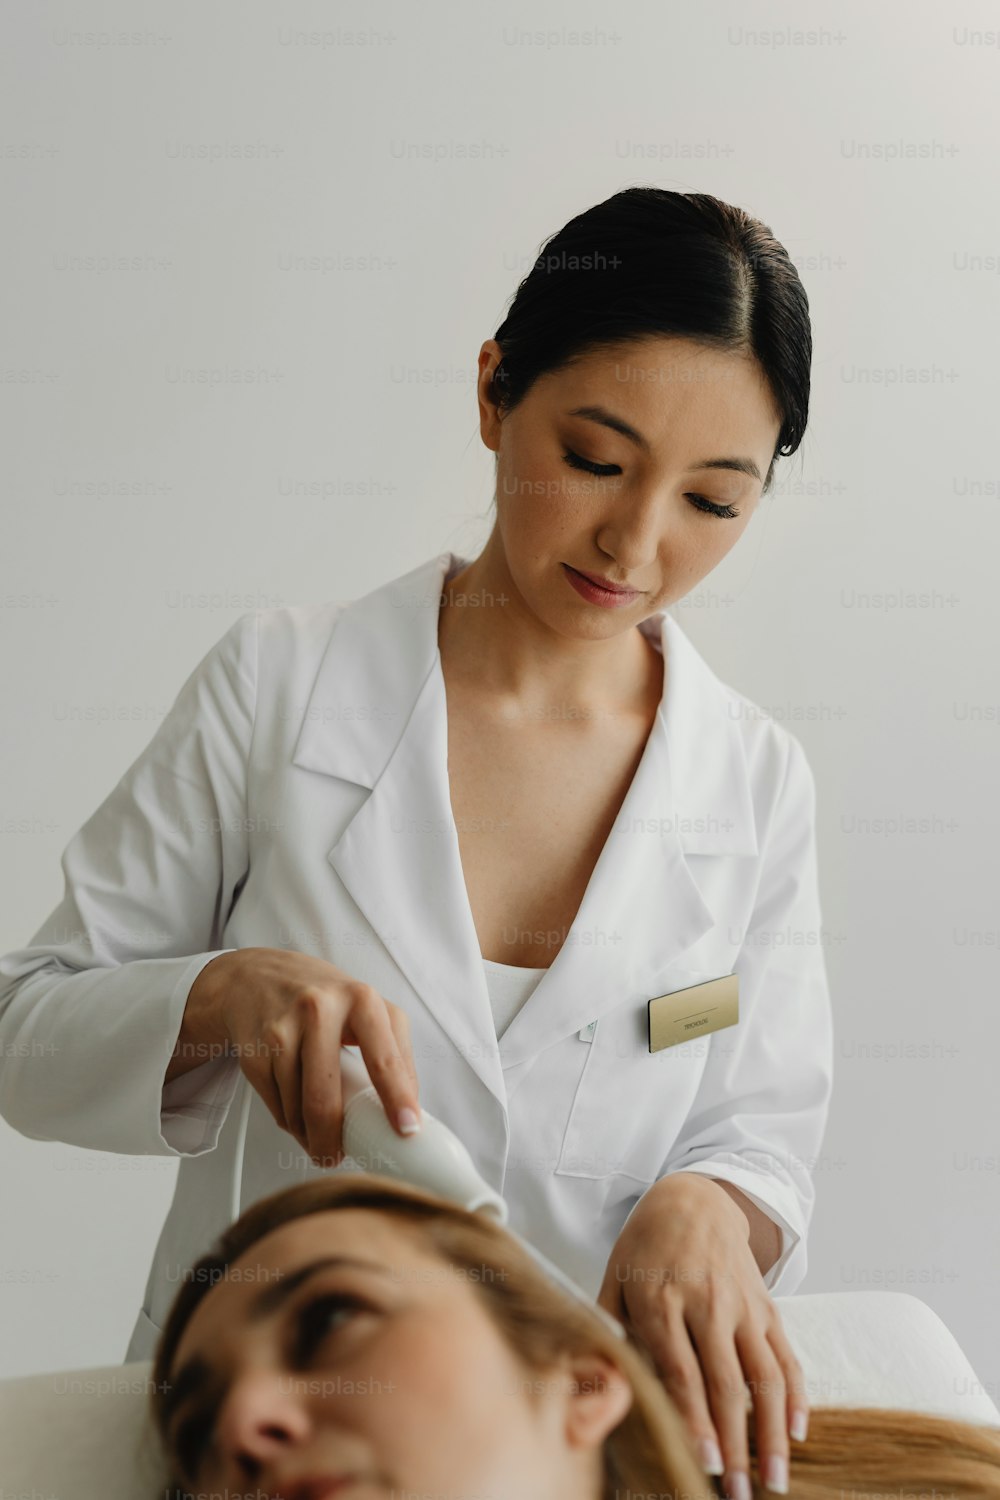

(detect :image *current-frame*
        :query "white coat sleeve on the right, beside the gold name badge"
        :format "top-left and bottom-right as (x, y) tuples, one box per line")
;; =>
(644, 731), (834, 1296)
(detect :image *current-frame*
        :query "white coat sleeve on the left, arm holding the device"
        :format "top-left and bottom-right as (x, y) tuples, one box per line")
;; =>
(0, 611), (256, 1157)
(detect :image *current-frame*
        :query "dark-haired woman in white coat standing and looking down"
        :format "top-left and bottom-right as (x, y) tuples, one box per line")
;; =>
(0, 188), (832, 1494)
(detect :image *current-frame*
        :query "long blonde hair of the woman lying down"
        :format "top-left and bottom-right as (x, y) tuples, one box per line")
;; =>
(150, 1172), (1000, 1500)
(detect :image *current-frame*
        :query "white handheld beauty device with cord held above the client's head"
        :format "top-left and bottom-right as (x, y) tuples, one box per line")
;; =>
(232, 1047), (625, 1338)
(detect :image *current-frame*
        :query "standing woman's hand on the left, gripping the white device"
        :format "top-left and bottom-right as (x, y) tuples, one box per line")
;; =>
(187, 948), (420, 1167)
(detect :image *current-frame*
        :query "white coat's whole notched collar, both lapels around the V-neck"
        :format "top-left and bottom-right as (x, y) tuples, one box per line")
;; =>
(292, 552), (757, 1106)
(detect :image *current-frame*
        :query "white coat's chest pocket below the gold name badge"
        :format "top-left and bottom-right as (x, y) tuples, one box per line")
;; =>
(555, 968), (726, 1184)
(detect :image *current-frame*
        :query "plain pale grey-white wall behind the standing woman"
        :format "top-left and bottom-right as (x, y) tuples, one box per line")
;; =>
(0, 0), (1000, 1404)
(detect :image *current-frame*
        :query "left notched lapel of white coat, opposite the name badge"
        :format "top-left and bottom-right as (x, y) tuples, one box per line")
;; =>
(292, 552), (507, 1107)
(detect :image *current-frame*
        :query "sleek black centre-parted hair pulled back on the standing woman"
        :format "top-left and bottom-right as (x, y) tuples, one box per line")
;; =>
(493, 186), (813, 489)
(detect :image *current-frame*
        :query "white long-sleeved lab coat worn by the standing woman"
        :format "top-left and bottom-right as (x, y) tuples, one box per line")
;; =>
(0, 552), (832, 1361)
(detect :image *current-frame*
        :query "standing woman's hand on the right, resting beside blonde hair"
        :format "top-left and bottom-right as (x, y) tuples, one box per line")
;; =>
(598, 1172), (808, 1500)
